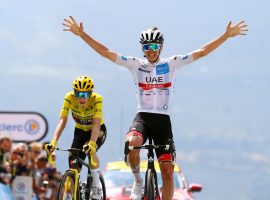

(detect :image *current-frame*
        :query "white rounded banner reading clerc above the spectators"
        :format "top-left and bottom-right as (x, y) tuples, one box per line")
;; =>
(0, 112), (48, 142)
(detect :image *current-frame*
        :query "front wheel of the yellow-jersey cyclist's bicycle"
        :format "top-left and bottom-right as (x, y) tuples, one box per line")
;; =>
(57, 170), (81, 200)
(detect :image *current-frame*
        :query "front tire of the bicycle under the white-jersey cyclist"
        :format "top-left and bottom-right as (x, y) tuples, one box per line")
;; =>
(144, 169), (156, 200)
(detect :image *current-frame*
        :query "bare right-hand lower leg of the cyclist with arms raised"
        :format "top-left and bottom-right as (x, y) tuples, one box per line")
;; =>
(159, 162), (174, 200)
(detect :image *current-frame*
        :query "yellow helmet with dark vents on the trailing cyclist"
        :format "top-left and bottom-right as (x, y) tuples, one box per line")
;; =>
(72, 75), (95, 92)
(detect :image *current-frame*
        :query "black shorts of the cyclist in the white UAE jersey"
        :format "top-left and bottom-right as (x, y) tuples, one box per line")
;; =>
(129, 112), (173, 161)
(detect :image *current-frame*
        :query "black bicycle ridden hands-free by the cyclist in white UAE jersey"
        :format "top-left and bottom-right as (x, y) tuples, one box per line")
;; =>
(125, 137), (175, 200)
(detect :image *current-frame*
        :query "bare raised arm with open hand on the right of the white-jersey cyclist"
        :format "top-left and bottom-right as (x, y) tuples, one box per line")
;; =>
(192, 21), (248, 60)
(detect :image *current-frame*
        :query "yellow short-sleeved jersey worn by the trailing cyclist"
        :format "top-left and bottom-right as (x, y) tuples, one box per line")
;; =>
(60, 92), (104, 131)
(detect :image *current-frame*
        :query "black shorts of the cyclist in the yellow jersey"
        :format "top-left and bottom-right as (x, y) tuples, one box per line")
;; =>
(68, 124), (107, 167)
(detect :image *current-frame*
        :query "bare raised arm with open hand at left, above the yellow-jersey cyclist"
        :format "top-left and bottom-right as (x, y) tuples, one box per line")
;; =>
(63, 16), (117, 62)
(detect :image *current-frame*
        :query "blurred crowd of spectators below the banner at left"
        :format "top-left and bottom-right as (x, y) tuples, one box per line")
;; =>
(0, 135), (61, 200)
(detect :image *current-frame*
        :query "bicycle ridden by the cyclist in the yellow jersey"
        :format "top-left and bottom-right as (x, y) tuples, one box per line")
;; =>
(56, 148), (106, 200)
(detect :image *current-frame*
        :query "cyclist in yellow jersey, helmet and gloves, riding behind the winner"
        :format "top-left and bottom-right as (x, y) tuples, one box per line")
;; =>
(45, 75), (106, 199)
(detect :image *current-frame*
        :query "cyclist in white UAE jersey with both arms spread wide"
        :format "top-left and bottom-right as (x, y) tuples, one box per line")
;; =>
(63, 16), (248, 200)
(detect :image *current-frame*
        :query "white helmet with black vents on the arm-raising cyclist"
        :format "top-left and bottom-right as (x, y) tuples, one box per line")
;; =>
(140, 27), (164, 44)
